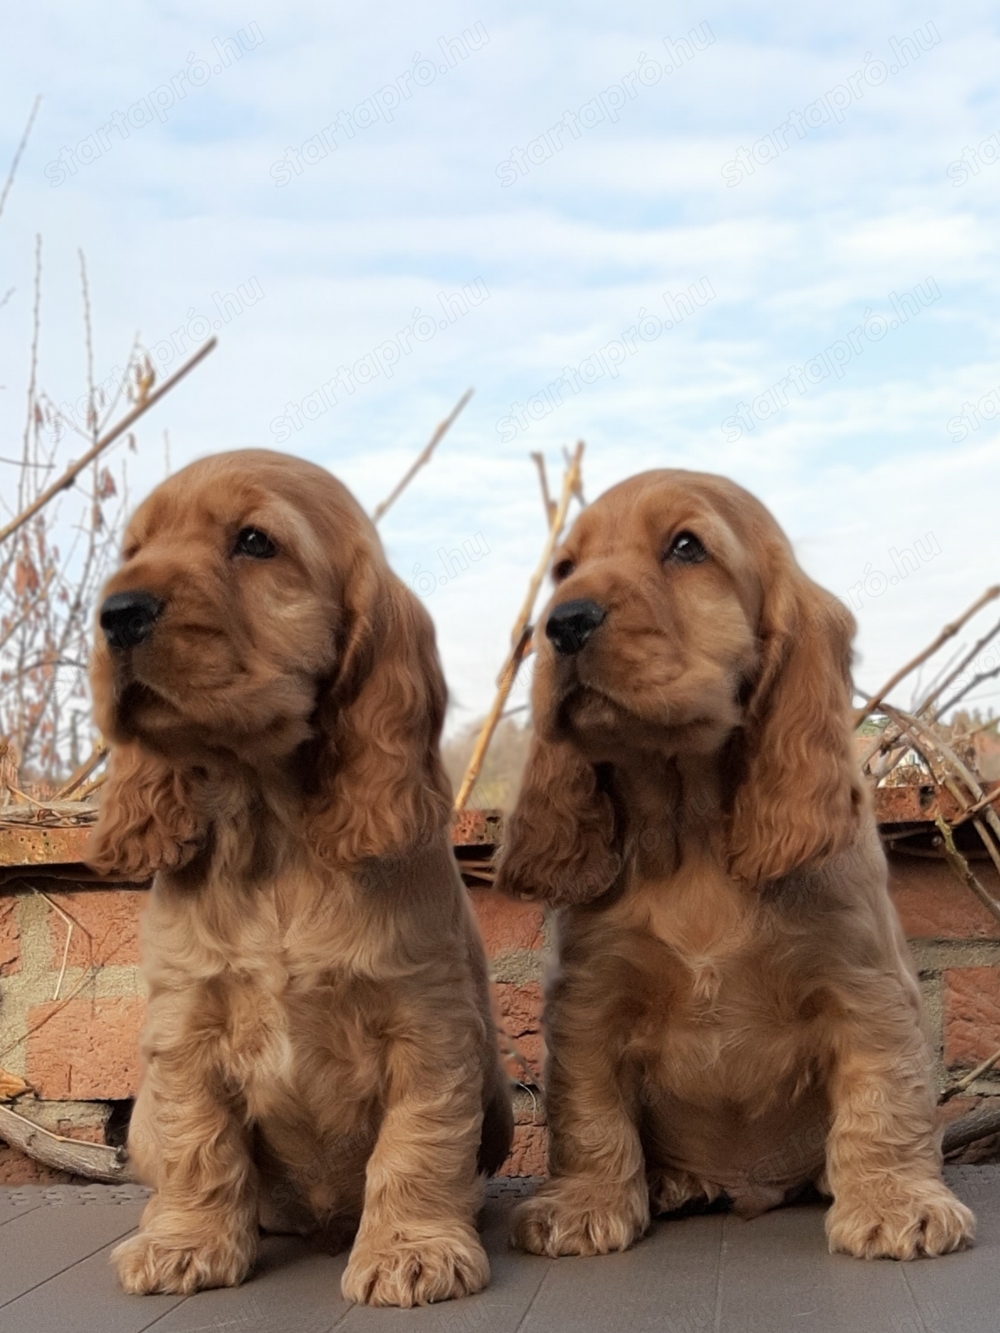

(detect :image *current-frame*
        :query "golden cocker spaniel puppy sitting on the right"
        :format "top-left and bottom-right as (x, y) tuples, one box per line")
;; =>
(499, 471), (973, 1258)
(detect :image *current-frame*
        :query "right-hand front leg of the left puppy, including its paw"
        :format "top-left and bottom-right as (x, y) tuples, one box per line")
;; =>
(341, 996), (489, 1306)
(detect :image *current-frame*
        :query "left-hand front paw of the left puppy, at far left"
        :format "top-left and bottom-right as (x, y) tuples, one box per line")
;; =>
(111, 1232), (256, 1296)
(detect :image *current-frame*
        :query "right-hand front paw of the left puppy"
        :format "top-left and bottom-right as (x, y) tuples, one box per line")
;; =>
(340, 1226), (489, 1308)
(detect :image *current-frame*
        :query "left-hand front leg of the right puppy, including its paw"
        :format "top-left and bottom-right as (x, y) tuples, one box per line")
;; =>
(512, 1005), (649, 1257)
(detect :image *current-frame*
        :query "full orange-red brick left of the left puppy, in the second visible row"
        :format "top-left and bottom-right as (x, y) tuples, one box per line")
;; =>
(27, 996), (145, 1101)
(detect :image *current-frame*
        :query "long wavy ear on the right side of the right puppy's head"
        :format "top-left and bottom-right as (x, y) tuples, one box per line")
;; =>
(729, 567), (863, 885)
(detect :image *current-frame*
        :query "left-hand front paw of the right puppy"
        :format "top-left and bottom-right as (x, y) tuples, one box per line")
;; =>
(511, 1180), (649, 1258)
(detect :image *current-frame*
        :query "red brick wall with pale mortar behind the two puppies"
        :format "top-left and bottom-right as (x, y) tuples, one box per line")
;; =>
(0, 837), (1000, 1181)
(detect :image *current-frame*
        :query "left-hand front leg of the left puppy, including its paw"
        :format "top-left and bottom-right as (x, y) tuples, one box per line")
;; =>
(111, 1029), (257, 1296)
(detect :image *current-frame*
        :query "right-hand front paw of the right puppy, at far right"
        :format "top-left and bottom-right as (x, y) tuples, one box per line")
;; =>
(827, 1180), (976, 1258)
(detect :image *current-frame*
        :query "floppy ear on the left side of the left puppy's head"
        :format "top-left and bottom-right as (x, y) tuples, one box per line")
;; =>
(87, 744), (205, 882)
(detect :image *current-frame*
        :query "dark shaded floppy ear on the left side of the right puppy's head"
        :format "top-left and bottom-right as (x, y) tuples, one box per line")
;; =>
(496, 736), (623, 908)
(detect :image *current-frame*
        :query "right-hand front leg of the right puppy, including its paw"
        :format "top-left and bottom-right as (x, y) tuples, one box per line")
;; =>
(827, 1005), (976, 1258)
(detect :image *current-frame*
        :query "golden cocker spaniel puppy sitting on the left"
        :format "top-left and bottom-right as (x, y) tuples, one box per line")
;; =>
(89, 451), (512, 1305)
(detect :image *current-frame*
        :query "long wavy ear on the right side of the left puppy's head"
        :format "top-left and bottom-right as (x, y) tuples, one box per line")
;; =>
(308, 567), (451, 865)
